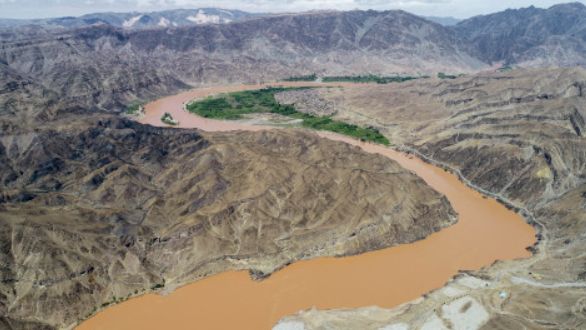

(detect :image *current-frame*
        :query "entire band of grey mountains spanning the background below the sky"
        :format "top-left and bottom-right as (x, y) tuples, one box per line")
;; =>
(0, 3), (586, 121)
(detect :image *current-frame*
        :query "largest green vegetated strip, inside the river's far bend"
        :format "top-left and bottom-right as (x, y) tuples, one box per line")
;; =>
(187, 88), (389, 145)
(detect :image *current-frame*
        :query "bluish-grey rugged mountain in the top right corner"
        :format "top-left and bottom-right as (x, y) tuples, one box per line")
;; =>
(455, 2), (586, 66)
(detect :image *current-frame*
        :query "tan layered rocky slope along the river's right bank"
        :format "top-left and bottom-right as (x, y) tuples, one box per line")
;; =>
(278, 69), (586, 329)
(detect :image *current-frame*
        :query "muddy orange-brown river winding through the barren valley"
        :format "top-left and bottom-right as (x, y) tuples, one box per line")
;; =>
(78, 83), (535, 330)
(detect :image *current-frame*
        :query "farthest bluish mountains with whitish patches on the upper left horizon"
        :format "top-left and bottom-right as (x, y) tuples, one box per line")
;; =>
(0, 8), (257, 29)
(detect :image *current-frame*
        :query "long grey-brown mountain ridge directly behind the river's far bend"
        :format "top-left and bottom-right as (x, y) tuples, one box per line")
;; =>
(0, 11), (484, 110)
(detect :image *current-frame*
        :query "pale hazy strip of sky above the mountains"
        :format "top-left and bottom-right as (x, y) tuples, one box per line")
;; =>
(0, 0), (586, 18)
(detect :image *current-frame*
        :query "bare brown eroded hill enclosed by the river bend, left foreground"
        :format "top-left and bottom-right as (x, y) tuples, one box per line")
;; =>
(0, 93), (455, 329)
